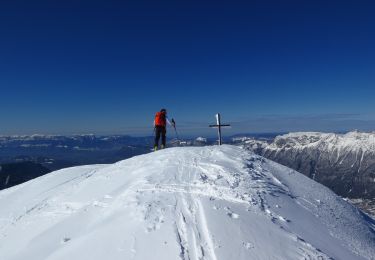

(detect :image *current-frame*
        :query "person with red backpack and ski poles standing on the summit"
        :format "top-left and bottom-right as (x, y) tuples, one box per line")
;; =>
(154, 108), (176, 151)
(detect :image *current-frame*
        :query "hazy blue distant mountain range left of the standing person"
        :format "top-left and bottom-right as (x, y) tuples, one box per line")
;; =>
(0, 135), (153, 170)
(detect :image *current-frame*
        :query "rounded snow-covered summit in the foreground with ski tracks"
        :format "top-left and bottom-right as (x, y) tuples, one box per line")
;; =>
(0, 146), (375, 260)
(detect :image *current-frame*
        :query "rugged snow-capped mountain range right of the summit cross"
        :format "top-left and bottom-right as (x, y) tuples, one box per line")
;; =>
(239, 132), (375, 199)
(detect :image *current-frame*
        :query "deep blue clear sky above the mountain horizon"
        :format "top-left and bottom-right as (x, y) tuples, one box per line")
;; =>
(0, 0), (375, 135)
